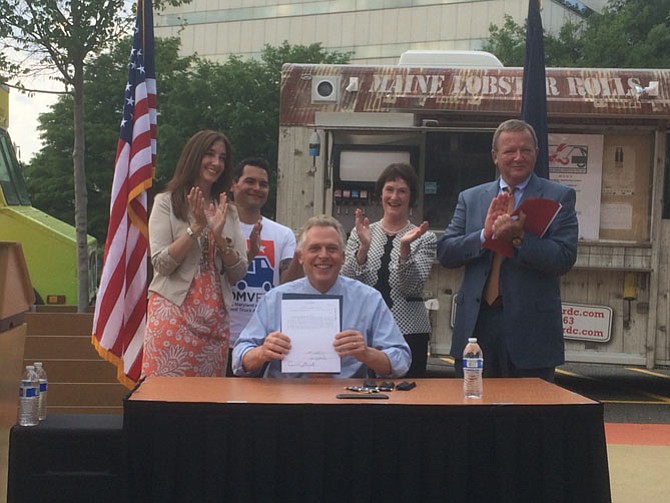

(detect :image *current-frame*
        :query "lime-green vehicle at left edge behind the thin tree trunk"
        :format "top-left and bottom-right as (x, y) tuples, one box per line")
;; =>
(0, 128), (98, 306)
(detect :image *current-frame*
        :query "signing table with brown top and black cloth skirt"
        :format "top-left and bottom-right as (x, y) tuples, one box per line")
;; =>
(124, 377), (611, 503)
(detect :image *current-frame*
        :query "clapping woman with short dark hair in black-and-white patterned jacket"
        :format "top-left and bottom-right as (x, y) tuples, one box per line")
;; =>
(342, 163), (436, 377)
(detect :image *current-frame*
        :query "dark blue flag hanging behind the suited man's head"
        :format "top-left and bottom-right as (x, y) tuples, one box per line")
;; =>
(521, 0), (549, 178)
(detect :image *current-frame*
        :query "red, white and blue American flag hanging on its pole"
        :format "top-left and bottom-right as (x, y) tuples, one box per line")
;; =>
(92, 0), (156, 388)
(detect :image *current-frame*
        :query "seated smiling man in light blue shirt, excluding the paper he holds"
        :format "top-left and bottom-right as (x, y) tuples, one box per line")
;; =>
(233, 216), (411, 378)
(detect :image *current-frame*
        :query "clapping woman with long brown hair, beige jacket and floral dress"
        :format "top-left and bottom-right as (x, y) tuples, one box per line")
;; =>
(142, 130), (247, 376)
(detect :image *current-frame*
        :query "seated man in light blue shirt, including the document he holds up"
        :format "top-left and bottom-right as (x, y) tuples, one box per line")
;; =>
(233, 216), (411, 378)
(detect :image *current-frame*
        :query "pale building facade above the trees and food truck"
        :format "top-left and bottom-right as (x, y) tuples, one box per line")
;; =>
(155, 0), (606, 64)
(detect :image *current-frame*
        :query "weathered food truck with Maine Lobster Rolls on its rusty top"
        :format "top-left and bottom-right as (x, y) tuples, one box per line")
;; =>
(277, 51), (670, 368)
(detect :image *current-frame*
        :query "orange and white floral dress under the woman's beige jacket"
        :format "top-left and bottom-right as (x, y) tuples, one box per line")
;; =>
(142, 233), (230, 377)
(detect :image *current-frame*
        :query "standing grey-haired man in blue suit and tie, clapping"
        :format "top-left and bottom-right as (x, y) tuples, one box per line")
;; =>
(437, 119), (578, 382)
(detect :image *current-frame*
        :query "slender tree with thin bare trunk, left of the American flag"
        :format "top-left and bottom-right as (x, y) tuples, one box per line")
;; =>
(0, 0), (188, 312)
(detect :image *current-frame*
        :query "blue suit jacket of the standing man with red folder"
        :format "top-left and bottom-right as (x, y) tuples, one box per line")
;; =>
(437, 174), (578, 369)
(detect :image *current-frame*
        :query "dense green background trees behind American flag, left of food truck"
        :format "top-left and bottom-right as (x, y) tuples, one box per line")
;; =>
(25, 38), (349, 243)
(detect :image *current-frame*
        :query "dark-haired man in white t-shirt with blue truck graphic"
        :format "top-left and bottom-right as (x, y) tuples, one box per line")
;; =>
(231, 157), (303, 375)
